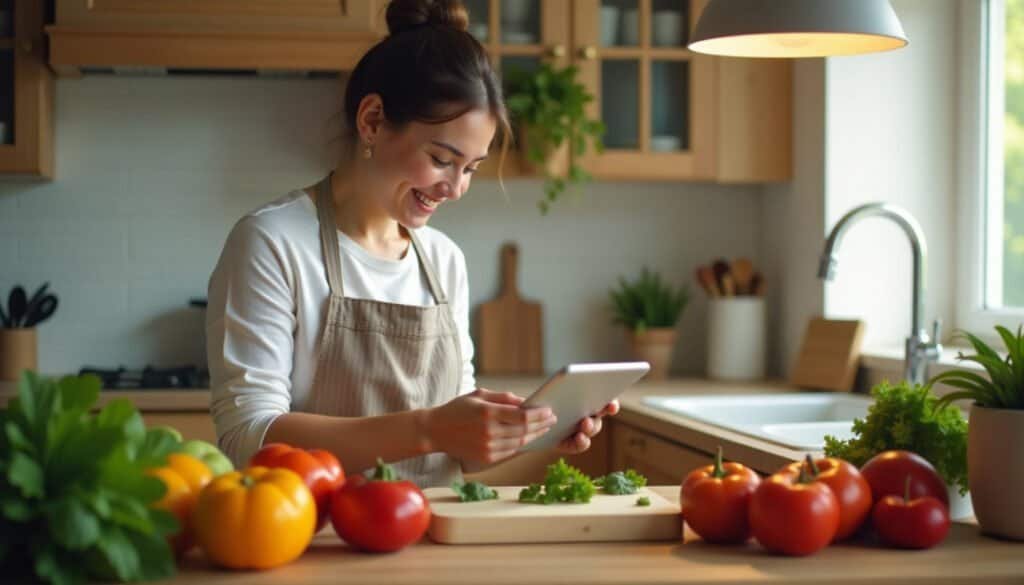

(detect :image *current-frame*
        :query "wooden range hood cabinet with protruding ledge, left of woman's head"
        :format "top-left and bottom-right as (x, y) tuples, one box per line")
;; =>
(48, 0), (385, 74)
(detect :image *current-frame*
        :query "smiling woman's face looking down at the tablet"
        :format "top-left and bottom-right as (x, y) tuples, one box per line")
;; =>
(373, 110), (497, 228)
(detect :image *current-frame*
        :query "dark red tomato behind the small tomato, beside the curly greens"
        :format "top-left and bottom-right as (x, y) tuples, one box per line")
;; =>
(860, 451), (949, 508)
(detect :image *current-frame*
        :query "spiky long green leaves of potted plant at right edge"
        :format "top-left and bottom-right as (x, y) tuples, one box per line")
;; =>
(928, 326), (1024, 410)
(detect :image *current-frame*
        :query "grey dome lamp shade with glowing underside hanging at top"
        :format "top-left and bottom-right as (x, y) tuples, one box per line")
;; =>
(689, 0), (907, 58)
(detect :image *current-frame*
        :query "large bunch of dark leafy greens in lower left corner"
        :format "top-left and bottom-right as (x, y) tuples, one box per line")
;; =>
(0, 372), (179, 584)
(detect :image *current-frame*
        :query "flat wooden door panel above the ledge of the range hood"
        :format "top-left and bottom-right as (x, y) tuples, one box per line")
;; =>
(57, 0), (383, 33)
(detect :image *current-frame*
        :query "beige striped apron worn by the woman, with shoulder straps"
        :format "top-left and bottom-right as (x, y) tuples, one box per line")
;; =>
(307, 175), (462, 488)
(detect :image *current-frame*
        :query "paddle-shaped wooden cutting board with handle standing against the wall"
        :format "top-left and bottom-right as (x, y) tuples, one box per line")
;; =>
(477, 244), (544, 375)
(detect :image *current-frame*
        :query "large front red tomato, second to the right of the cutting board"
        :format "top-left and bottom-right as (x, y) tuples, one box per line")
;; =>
(751, 465), (840, 556)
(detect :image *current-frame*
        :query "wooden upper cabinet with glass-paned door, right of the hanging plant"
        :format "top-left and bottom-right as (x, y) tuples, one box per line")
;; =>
(572, 0), (793, 182)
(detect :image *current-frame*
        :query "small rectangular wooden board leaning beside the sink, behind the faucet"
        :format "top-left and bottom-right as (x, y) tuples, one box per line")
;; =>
(790, 317), (864, 392)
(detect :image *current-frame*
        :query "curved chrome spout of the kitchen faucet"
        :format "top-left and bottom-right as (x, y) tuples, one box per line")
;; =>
(818, 203), (928, 337)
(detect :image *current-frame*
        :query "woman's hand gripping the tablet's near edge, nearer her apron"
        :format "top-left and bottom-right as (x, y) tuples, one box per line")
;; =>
(424, 388), (557, 464)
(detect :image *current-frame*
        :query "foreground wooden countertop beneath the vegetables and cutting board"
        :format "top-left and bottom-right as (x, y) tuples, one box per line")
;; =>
(164, 486), (1024, 585)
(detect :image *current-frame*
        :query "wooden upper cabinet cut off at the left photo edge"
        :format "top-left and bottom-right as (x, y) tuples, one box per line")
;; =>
(0, 0), (53, 178)
